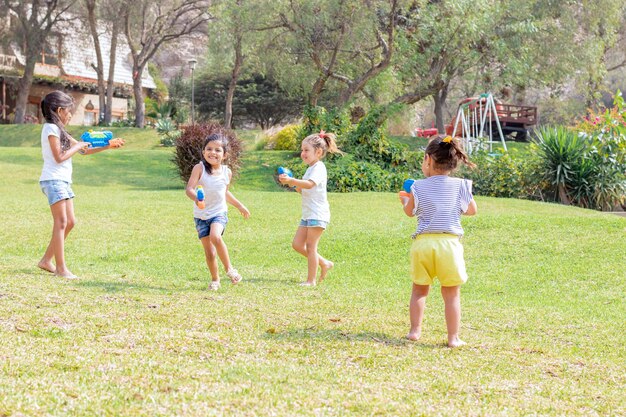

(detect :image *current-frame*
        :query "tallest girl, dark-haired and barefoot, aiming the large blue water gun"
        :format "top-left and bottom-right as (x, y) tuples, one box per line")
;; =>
(37, 91), (124, 279)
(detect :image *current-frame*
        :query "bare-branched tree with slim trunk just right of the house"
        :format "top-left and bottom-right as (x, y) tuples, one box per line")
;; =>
(121, 0), (211, 127)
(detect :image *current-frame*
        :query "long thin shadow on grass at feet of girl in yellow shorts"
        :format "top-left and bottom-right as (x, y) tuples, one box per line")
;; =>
(265, 327), (438, 349)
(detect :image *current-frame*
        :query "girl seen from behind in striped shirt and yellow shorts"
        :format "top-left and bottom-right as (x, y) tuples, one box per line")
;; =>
(401, 135), (477, 347)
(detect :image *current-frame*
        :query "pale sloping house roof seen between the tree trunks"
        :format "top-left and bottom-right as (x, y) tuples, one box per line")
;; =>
(12, 19), (156, 89)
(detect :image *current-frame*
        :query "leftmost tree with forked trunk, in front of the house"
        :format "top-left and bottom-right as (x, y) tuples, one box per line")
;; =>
(3, 0), (76, 124)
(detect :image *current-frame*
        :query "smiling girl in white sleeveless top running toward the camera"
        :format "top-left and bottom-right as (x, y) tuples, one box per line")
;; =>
(185, 133), (250, 291)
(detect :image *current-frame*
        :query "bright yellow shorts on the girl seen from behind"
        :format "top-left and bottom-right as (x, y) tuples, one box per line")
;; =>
(410, 234), (467, 287)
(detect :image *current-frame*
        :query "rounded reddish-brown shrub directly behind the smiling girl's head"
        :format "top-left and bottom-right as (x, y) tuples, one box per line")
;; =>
(172, 123), (243, 183)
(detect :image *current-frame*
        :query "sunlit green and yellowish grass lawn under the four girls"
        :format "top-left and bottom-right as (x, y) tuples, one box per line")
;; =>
(0, 127), (626, 416)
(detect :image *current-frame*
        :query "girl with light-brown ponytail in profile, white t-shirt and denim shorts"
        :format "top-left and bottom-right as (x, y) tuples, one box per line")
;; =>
(278, 130), (341, 286)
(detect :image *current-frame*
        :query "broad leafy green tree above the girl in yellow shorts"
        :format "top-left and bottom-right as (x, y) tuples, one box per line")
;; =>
(394, 0), (578, 132)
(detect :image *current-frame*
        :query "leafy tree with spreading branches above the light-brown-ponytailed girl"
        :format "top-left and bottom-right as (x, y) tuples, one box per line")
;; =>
(278, 0), (404, 106)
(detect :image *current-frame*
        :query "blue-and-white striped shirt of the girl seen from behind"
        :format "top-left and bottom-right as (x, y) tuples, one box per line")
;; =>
(411, 175), (474, 238)
